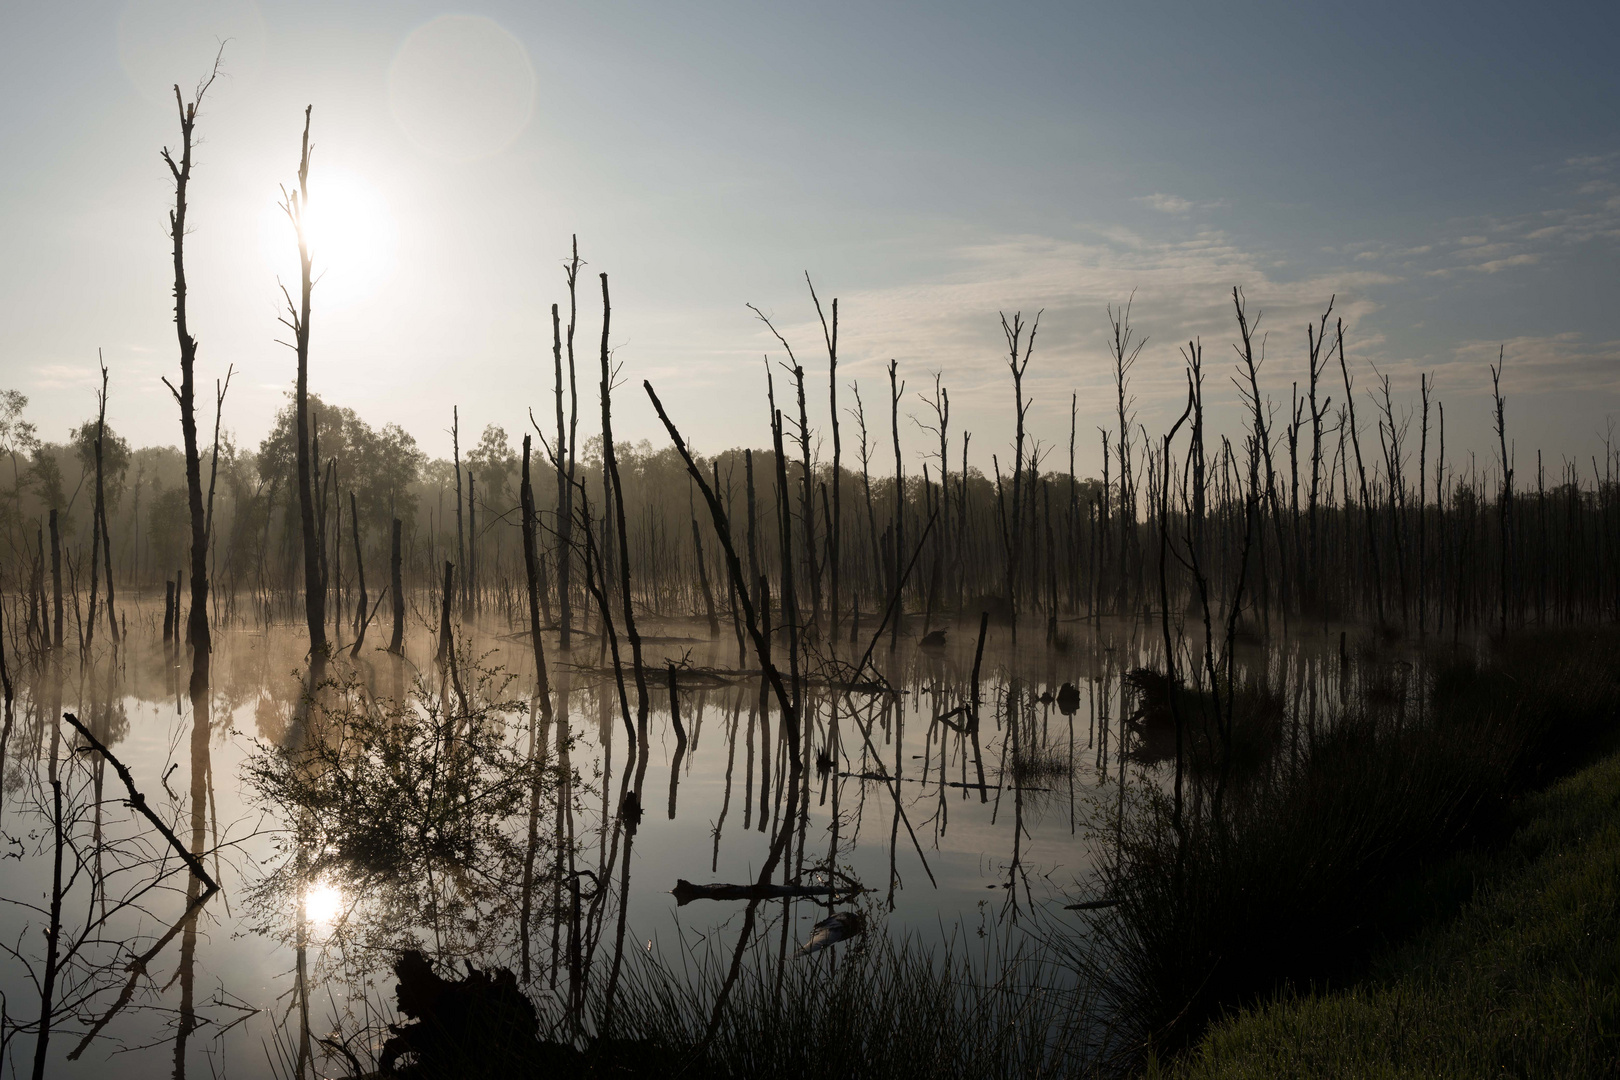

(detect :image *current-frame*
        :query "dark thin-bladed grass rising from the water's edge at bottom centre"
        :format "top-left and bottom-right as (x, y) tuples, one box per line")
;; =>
(576, 933), (1090, 1080)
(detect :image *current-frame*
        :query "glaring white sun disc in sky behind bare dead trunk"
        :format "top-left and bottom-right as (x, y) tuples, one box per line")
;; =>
(262, 169), (399, 309)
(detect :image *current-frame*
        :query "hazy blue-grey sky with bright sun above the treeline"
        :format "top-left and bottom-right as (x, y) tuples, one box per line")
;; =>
(0, 0), (1620, 474)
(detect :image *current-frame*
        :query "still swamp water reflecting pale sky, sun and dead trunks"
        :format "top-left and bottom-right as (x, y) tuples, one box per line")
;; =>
(0, 601), (1418, 1080)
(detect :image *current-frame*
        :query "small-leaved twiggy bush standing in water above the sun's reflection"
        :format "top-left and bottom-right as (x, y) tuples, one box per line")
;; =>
(245, 656), (583, 960)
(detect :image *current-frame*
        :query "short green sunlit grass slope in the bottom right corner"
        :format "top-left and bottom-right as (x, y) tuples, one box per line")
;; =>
(1147, 756), (1620, 1080)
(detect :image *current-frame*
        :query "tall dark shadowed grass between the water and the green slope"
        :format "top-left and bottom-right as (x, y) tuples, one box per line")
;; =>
(1072, 631), (1620, 1067)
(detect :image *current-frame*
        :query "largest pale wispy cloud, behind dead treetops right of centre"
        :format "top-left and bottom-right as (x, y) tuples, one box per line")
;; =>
(745, 230), (1400, 445)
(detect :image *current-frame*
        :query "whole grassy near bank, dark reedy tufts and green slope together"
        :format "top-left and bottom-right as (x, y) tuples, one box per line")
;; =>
(285, 631), (1620, 1080)
